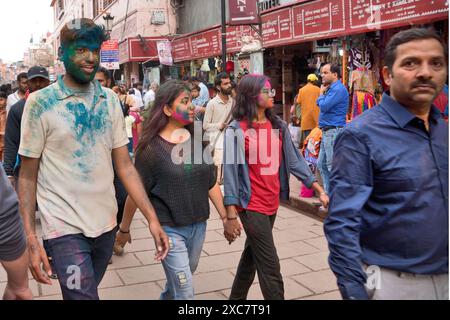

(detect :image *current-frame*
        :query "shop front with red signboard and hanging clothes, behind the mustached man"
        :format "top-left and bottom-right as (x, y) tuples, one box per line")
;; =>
(255, 0), (448, 121)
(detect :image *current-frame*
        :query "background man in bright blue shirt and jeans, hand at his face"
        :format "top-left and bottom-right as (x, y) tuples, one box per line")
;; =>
(317, 64), (348, 193)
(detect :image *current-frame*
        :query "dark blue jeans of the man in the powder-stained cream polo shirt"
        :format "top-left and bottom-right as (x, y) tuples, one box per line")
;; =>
(44, 228), (116, 300)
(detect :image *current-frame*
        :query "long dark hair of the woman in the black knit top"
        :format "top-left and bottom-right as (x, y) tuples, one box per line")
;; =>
(136, 80), (191, 153)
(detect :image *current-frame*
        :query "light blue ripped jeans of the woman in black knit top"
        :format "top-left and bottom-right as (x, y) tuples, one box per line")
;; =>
(160, 222), (206, 300)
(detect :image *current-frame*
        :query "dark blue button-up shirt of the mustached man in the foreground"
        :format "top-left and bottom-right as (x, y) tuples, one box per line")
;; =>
(325, 94), (449, 299)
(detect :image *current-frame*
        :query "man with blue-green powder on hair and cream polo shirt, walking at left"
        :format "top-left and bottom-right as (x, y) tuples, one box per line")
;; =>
(19, 18), (169, 300)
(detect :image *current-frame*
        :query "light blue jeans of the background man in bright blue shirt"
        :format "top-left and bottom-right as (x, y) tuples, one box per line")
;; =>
(317, 128), (343, 194)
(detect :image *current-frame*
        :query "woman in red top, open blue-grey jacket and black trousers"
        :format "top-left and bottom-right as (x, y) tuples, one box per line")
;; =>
(224, 75), (329, 300)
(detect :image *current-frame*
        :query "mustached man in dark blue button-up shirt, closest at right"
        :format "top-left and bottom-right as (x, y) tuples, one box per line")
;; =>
(325, 29), (449, 299)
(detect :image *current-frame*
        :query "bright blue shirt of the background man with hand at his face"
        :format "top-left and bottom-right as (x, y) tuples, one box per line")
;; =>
(317, 80), (349, 128)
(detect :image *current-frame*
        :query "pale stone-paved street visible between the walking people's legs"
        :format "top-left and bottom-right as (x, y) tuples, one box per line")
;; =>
(0, 207), (340, 300)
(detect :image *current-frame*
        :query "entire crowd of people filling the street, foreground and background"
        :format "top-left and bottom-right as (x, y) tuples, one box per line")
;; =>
(0, 19), (448, 300)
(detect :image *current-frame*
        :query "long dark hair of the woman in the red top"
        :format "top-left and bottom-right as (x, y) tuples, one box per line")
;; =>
(233, 74), (280, 128)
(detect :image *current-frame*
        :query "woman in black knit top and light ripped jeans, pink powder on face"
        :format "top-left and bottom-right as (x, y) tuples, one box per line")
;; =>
(117, 80), (240, 300)
